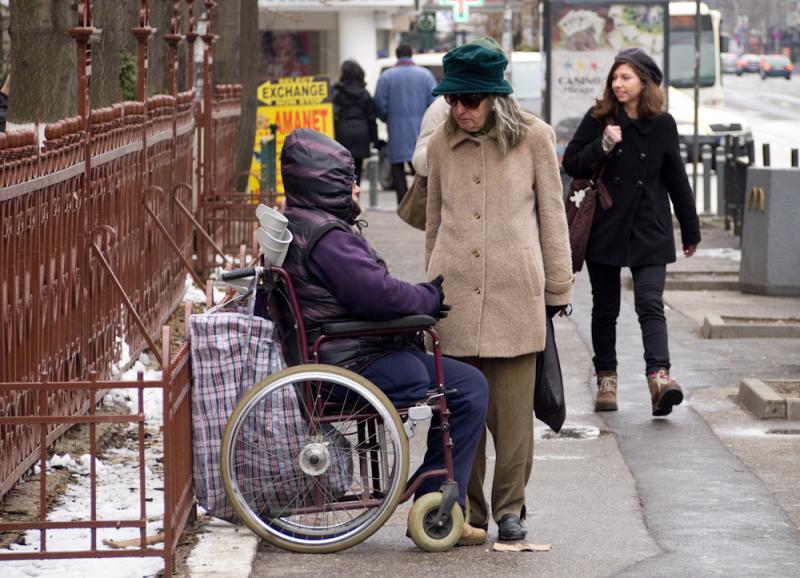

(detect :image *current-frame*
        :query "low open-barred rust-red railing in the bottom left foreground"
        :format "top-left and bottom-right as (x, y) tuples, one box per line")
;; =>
(0, 327), (192, 576)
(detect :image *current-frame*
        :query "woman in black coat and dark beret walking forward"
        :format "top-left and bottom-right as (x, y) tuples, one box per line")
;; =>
(563, 48), (700, 416)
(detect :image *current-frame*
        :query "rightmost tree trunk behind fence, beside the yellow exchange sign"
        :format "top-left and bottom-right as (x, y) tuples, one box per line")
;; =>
(213, 0), (258, 186)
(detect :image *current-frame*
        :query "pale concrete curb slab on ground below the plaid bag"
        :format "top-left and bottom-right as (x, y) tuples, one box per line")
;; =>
(186, 517), (258, 578)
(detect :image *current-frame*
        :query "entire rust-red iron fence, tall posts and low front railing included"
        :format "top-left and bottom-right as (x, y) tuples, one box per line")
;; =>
(0, 0), (253, 575)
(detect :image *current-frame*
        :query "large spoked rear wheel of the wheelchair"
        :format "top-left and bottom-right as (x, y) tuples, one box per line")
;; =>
(221, 365), (409, 553)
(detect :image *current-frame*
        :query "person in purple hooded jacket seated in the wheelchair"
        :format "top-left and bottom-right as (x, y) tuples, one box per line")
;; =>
(281, 129), (489, 545)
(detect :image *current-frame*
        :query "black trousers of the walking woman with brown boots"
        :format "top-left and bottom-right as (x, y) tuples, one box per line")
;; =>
(586, 261), (670, 373)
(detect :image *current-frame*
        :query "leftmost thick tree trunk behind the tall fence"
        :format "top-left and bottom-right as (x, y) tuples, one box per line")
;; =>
(8, 0), (78, 123)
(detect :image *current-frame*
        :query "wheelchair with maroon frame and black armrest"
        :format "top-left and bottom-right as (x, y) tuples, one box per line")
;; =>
(216, 267), (464, 553)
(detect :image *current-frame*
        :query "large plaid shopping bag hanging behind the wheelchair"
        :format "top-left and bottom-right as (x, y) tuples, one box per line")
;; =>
(189, 290), (353, 521)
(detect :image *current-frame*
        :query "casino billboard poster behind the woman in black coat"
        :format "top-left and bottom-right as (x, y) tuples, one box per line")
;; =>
(546, 1), (667, 158)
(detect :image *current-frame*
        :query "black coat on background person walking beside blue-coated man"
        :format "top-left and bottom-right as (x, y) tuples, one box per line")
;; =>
(333, 83), (378, 159)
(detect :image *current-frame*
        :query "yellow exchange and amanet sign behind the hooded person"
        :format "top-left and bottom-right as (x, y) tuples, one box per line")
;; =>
(249, 76), (333, 193)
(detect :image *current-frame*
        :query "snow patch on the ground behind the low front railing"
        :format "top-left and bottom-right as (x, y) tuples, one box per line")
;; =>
(0, 354), (164, 578)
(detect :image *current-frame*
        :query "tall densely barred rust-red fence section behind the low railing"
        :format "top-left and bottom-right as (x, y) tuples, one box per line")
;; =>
(0, 92), (194, 495)
